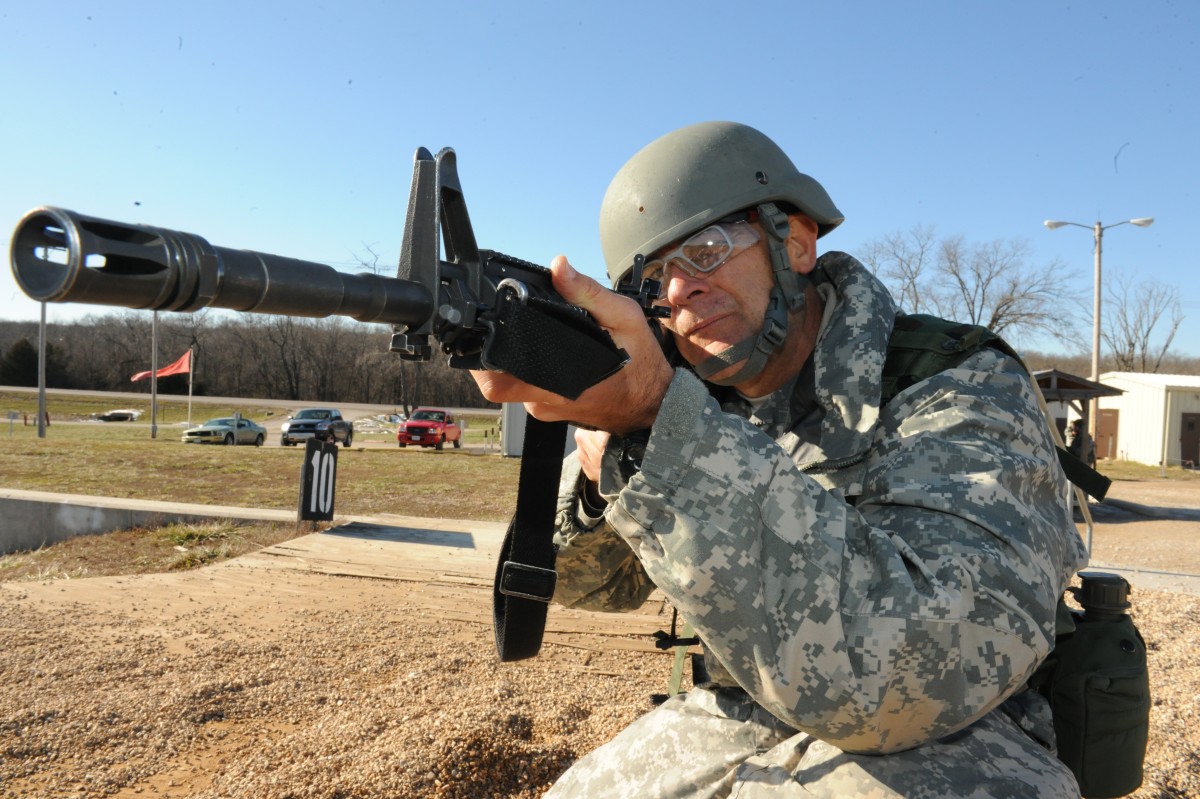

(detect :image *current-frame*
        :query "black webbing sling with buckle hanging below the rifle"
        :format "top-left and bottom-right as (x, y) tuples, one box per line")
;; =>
(492, 416), (566, 662)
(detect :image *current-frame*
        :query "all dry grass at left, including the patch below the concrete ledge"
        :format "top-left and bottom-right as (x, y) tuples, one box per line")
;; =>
(0, 392), (520, 581)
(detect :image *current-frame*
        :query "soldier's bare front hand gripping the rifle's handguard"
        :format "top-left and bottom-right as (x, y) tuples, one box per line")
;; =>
(472, 256), (674, 434)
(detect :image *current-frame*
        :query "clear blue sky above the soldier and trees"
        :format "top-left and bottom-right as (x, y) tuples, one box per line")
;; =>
(0, 0), (1200, 355)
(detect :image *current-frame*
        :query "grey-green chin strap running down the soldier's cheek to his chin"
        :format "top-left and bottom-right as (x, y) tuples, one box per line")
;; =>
(694, 203), (810, 385)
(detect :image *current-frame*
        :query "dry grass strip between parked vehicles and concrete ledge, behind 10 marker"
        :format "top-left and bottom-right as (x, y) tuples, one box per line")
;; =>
(0, 423), (520, 521)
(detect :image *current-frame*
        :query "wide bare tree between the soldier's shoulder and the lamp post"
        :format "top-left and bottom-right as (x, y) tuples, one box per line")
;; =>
(863, 226), (1078, 336)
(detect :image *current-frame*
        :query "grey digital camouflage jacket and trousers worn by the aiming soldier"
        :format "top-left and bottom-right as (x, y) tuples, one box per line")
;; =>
(548, 253), (1086, 798)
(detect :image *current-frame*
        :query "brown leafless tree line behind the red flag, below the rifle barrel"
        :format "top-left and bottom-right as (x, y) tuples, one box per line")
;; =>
(0, 311), (494, 413)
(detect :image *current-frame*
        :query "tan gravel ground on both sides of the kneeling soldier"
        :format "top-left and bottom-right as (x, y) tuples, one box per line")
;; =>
(0, 475), (1200, 799)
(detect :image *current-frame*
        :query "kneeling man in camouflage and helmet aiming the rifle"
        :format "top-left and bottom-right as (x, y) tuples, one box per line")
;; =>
(475, 122), (1086, 799)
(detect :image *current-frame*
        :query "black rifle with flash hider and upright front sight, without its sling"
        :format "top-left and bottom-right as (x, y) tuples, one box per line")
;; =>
(11, 148), (661, 400)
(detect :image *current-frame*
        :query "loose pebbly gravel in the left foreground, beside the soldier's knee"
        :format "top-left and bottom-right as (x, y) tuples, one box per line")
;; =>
(0, 590), (665, 799)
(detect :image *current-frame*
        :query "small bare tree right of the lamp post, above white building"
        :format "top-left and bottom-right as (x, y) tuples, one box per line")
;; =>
(1100, 275), (1183, 372)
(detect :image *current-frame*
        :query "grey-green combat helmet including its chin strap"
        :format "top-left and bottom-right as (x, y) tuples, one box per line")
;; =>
(600, 122), (845, 384)
